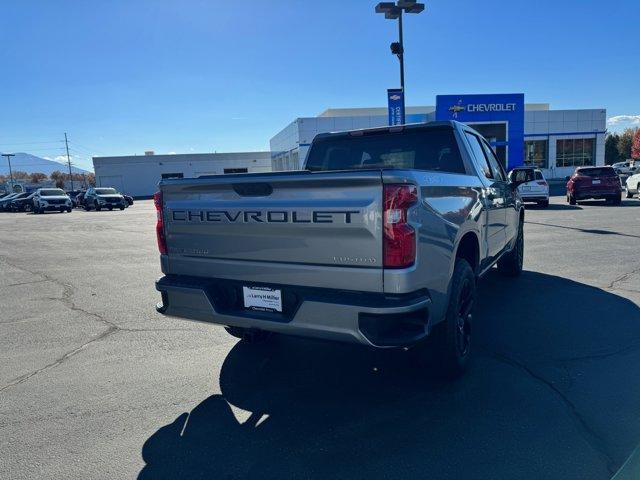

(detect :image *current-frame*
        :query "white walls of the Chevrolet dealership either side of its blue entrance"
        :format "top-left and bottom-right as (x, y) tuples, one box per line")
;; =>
(270, 103), (606, 178)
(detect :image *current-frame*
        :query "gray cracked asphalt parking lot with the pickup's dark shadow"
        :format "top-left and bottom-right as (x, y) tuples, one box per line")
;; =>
(0, 197), (640, 480)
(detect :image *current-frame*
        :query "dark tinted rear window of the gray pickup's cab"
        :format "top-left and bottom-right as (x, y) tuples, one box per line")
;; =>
(306, 128), (466, 174)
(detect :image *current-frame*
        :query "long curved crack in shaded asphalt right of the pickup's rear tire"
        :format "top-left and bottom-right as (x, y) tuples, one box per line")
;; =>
(482, 349), (615, 474)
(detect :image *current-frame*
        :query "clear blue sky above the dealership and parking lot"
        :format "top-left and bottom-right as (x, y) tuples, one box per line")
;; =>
(0, 0), (640, 171)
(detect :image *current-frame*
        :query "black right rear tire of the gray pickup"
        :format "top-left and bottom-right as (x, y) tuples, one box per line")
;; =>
(410, 258), (476, 379)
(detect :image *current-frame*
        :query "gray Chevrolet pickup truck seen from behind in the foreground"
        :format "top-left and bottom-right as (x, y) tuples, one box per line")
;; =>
(154, 122), (524, 376)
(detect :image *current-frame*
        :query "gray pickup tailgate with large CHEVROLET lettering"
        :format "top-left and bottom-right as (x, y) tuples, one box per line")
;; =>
(161, 171), (383, 292)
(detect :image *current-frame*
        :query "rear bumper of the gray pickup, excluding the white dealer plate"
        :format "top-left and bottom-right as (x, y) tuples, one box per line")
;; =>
(156, 275), (431, 347)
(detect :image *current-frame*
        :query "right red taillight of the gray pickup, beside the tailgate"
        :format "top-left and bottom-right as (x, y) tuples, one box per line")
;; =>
(383, 184), (418, 268)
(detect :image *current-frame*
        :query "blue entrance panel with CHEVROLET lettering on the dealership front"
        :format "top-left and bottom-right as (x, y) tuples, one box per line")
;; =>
(436, 93), (524, 169)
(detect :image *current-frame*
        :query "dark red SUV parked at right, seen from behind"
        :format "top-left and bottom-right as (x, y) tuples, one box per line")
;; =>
(567, 167), (622, 205)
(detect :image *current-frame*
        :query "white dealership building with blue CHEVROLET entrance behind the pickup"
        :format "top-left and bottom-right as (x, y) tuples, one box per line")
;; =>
(270, 94), (606, 178)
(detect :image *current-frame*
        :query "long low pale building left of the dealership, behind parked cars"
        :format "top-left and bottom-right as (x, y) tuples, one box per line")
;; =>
(93, 152), (271, 197)
